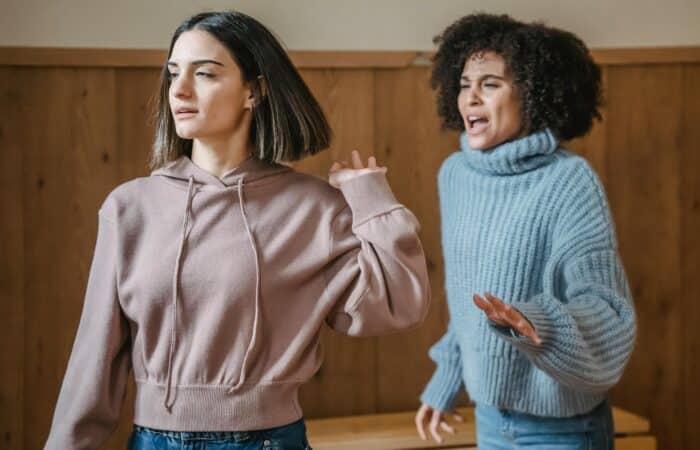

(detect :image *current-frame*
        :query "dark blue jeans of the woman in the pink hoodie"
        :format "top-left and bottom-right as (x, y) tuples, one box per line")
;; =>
(127, 419), (311, 450)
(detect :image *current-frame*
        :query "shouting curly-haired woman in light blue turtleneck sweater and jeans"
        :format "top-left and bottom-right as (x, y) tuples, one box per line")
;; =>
(416, 14), (636, 449)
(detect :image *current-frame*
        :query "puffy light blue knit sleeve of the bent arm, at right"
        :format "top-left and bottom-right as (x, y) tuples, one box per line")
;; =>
(492, 165), (636, 392)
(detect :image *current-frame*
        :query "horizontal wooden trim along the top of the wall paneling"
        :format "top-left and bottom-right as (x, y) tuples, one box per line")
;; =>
(0, 46), (700, 69)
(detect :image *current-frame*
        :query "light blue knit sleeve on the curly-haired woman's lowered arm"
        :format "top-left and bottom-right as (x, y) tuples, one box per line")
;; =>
(420, 326), (463, 412)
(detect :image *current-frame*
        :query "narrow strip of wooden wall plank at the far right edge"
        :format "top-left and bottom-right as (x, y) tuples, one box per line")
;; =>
(676, 64), (700, 448)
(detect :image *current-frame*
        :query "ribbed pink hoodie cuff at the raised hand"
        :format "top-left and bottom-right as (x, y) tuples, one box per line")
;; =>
(340, 171), (403, 226)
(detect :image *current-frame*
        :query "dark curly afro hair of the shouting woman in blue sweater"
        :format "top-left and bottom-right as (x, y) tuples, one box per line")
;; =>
(431, 14), (602, 140)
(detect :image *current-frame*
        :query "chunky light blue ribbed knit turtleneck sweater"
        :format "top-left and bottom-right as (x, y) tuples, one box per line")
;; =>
(421, 131), (636, 417)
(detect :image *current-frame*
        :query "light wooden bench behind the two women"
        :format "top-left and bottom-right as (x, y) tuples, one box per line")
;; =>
(306, 408), (656, 450)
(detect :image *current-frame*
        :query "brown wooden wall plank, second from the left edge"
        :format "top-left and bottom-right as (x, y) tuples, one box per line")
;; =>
(24, 68), (79, 449)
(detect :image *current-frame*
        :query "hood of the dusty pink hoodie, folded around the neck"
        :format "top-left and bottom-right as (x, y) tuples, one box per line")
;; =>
(151, 155), (291, 190)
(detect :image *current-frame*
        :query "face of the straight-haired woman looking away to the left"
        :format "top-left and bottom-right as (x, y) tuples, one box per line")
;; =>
(168, 30), (253, 139)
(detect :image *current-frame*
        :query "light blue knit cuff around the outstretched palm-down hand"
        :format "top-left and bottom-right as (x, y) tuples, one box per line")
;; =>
(490, 301), (556, 356)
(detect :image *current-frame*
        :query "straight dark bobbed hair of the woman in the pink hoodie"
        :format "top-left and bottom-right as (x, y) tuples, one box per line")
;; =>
(150, 11), (331, 169)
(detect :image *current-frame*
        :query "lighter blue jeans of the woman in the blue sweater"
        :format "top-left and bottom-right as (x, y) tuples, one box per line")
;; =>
(476, 400), (615, 450)
